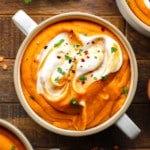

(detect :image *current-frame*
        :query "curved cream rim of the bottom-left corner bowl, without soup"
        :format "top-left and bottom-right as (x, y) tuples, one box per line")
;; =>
(0, 119), (33, 150)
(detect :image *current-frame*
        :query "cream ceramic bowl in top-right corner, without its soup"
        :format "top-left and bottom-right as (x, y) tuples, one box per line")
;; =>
(116, 0), (150, 37)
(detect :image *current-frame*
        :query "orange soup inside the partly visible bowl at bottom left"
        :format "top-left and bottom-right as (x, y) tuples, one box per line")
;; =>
(0, 127), (26, 150)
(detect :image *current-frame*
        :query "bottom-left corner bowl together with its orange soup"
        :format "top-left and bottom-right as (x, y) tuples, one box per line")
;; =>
(0, 119), (32, 150)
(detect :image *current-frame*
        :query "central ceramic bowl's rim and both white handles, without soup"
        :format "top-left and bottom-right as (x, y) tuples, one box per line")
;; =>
(13, 10), (140, 139)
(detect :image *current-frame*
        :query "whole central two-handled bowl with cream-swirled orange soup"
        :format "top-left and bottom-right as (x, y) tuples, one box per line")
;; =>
(13, 11), (140, 138)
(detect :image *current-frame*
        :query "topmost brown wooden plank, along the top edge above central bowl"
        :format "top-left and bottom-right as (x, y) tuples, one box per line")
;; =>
(0, 0), (120, 15)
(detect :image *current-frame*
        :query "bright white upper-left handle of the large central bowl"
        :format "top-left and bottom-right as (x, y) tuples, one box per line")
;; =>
(12, 10), (37, 35)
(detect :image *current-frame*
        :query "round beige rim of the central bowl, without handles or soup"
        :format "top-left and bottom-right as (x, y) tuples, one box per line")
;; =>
(14, 12), (138, 136)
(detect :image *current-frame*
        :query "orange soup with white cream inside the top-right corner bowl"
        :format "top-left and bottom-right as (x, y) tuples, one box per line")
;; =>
(127, 0), (150, 26)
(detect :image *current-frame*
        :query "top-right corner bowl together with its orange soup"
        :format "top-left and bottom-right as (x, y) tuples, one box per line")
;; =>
(116, 0), (150, 37)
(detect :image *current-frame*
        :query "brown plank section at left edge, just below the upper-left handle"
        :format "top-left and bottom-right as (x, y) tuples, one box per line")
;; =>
(0, 16), (24, 58)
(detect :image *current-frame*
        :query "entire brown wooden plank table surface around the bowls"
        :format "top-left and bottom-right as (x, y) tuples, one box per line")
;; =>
(0, 0), (150, 150)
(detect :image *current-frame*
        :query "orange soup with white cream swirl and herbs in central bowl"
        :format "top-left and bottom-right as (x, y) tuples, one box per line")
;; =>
(21, 20), (131, 130)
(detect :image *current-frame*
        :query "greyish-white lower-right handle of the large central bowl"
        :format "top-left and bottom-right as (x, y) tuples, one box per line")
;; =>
(116, 114), (141, 139)
